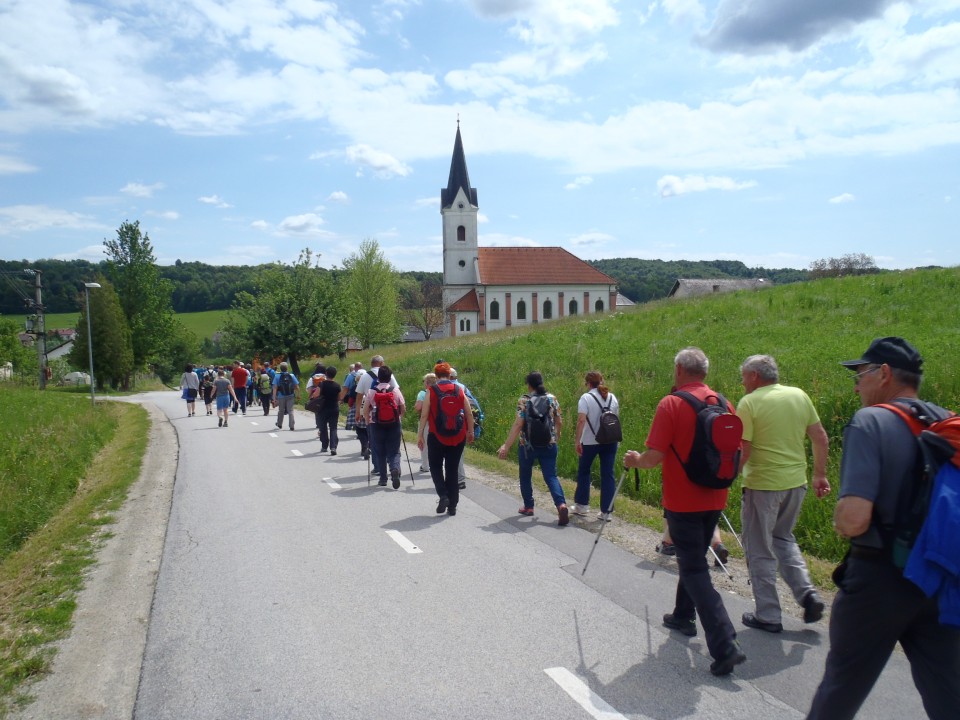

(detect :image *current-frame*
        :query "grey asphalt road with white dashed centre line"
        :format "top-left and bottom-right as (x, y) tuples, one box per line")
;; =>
(16, 393), (923, 720)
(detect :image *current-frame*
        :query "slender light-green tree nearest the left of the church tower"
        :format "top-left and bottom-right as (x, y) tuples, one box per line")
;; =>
(343, 239), (401, 348)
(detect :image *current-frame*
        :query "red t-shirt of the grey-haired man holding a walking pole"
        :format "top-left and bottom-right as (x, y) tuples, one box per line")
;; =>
(646, 382), (732, 512)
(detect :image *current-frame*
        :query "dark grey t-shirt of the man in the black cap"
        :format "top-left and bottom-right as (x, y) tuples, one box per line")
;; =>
(839, 401), (942, 548)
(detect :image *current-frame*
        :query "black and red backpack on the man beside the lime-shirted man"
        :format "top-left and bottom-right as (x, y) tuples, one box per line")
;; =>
(671, 390), (743, 490)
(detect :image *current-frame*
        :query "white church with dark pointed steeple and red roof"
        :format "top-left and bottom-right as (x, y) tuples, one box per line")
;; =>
(440, 121), (617, 337)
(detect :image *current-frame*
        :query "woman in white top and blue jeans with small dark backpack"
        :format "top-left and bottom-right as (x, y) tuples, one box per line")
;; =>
(573, 370), (620, 520)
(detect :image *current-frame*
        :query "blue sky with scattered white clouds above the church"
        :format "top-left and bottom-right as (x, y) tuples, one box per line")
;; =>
(0, 0), (960, 271)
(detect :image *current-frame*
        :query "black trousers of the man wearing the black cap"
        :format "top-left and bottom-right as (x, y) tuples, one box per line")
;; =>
(807, 557), (960, 720)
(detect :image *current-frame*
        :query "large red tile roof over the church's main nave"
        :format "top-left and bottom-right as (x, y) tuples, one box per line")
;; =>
(478, 247), (617, 285)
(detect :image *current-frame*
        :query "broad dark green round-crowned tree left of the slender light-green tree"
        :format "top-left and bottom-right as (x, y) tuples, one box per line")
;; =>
(222, 248), (347, 375)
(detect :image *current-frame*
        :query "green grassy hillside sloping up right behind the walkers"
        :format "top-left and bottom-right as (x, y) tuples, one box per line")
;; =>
(322, 268), (960, 558)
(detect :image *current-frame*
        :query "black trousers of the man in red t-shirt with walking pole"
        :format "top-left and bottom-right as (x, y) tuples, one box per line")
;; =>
(663, 510), (737, 660)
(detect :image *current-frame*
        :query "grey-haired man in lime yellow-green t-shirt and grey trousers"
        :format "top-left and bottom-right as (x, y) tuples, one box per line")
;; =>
(737, 355), (830, 633)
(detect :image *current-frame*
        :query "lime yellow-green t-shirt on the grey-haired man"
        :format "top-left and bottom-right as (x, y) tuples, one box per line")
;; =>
(737, 383), (820, 490)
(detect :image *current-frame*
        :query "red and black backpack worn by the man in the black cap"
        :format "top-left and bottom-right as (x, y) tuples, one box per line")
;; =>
(877, 400), (960, 570)
